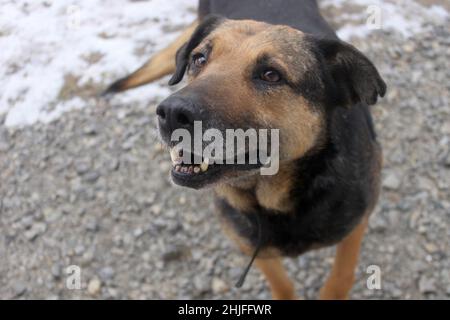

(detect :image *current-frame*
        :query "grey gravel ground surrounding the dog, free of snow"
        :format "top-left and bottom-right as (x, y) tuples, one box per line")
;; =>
(0, 5), (450, 299)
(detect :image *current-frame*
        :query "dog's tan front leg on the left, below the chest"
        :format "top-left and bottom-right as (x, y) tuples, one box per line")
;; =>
(255, 258), (297, 300)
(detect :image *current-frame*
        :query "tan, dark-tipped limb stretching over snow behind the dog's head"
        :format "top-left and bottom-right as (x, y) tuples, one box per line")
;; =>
(105, 21), (198, 94)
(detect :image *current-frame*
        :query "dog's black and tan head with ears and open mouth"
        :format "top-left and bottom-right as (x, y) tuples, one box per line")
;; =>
(157, 16), (386, 188)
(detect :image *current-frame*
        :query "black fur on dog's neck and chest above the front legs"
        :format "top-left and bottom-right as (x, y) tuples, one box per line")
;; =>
(217, 105), (379, 256)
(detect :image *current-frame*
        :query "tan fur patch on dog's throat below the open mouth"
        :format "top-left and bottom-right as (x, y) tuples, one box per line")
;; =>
(215, 162), (295, 213)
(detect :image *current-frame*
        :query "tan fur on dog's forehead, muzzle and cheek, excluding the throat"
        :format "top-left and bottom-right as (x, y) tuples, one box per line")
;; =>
(189, 21), (325, 169)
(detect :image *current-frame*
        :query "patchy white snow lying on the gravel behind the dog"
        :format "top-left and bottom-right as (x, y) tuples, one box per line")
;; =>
(0, 0), (448, 126)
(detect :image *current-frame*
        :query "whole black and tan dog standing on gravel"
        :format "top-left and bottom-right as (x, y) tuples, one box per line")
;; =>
(103, 0), (386, 299)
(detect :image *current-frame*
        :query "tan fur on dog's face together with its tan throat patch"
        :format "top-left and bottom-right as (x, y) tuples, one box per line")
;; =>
(185, 21), (325, 212)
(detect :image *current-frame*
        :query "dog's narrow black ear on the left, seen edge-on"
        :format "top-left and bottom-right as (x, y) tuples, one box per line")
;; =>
(169, 15), (224, 85)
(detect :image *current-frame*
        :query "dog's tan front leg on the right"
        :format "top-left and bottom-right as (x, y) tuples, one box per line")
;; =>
(320, 217), (368, 300)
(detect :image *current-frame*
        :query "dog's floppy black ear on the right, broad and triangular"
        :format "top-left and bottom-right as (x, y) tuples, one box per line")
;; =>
(317, 39), (386, 107)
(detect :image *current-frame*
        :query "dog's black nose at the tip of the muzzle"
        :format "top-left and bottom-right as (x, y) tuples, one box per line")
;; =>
(156, 96), (200, 135)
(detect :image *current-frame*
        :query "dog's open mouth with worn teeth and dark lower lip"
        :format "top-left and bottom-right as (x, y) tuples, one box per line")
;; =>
(170, 148), (261, 189)
